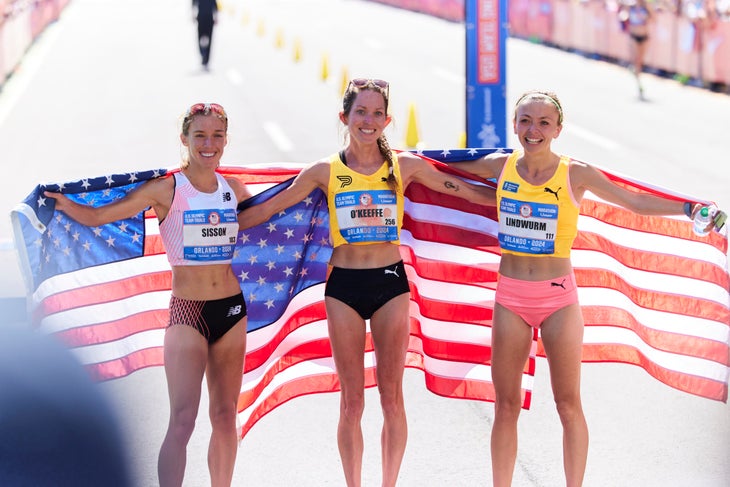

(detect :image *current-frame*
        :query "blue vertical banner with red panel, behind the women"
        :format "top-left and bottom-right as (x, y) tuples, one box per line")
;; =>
(464, 0), (507, 147)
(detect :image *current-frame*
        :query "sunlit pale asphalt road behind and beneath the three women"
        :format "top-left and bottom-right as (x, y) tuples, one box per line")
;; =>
(0, 0), (730, 487)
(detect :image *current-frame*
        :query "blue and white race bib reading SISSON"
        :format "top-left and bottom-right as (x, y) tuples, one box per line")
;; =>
(183, 208), (238, 261)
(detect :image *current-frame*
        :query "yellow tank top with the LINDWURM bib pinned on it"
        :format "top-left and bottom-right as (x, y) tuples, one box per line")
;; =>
(497, 151), (580, 257)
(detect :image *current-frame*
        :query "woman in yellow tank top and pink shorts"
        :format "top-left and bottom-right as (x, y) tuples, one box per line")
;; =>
(450, 91), (724, 487)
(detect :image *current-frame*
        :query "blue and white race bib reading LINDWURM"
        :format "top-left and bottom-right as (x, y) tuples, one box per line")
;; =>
(499, 198), (558, 254)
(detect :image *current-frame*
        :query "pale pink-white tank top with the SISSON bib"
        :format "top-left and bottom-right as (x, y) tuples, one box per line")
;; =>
(160, 172), (238, 266)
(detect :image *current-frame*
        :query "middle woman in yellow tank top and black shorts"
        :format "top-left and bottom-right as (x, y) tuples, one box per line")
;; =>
(239, 79), (495, 487)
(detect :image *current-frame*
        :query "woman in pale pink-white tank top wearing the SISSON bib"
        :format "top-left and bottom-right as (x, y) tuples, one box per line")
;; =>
(46, 103), (251, 487)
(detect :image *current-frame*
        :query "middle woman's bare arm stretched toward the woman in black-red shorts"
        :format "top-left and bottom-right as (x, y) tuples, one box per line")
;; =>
(238, 161), (329, 229)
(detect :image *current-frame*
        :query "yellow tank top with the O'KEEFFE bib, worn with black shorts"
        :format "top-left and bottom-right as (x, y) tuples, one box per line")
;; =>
(327, 153), (403, 248)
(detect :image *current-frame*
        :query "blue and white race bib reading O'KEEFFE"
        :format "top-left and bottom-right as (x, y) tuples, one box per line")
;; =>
(334, 190), (398, 244)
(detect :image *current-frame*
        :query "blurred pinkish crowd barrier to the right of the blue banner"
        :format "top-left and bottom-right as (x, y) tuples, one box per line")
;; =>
(508, 0), (730, 93)
